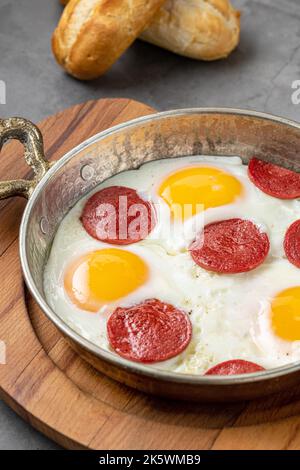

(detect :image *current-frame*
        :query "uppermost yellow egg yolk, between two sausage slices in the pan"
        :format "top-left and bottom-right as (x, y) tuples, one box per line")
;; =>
(158, 167), (243, 220)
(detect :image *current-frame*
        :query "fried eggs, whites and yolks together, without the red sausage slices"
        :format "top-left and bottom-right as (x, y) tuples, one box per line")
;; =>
(44, 156), (300, 374)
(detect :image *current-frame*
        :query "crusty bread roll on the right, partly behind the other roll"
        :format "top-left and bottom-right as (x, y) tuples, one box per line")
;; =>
(141, 0), (240, 60)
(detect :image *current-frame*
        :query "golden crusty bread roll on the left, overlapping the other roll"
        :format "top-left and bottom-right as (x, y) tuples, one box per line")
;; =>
(52, 0), (164, 80)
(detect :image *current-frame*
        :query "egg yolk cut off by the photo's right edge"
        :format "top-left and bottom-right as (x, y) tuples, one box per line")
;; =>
(271, 287), (300, 341)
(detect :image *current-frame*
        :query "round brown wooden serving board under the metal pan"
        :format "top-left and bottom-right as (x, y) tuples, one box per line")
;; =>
(0, 99), (300, 449)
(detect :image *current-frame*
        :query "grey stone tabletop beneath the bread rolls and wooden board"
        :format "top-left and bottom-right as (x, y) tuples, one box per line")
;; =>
(0, 0), (300, 449)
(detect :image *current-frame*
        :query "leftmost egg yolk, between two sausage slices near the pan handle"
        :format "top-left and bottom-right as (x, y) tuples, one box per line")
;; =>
(64, 248), (149, 312)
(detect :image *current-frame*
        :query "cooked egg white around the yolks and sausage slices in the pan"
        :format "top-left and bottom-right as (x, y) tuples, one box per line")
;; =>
(44, 156), (300, 374)
